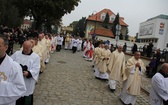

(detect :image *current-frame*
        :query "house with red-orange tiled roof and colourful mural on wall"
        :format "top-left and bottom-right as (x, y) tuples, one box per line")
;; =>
(85, 9), (128, 38)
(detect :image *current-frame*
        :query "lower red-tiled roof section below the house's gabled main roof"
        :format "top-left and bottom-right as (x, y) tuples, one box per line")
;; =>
(89, 28), (114, 38)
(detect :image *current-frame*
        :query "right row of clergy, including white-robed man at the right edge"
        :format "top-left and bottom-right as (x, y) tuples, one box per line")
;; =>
(92, 41), (168, 105)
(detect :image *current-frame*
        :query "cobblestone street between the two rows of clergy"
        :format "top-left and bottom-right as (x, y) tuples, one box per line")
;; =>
(31, 50), (149, 105)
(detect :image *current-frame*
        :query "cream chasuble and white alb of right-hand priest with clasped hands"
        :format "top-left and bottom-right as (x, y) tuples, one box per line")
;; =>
(119, 57), (146, 105)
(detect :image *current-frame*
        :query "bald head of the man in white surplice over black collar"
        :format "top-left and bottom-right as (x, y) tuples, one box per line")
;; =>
(23, 41), (32, 54)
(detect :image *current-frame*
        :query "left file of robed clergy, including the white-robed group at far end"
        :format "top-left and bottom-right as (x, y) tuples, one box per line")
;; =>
(0, 25), (92, 105)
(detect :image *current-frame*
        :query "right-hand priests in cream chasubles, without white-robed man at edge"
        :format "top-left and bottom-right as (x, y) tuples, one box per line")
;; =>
(93, 44), (146, 105)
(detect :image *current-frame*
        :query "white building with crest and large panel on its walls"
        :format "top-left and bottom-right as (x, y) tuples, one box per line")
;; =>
(138, 15), (168, 51)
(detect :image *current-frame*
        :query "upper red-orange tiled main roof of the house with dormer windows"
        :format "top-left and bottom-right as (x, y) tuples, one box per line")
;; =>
(87, 9), (128, 26)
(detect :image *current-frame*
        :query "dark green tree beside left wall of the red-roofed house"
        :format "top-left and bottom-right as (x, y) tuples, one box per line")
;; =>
(73, 17), (86, 37)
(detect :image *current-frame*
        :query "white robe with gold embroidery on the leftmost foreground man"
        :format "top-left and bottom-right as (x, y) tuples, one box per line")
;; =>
(0, 55), (26, 105)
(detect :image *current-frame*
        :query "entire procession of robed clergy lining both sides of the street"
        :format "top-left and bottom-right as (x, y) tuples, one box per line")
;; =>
(0, 25), (168, 105)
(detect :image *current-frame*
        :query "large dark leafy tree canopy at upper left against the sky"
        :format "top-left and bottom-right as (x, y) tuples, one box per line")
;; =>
(13, 0), (80, 29)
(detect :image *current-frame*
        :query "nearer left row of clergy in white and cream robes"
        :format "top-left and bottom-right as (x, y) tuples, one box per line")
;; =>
(0, 33), (55, 105)
